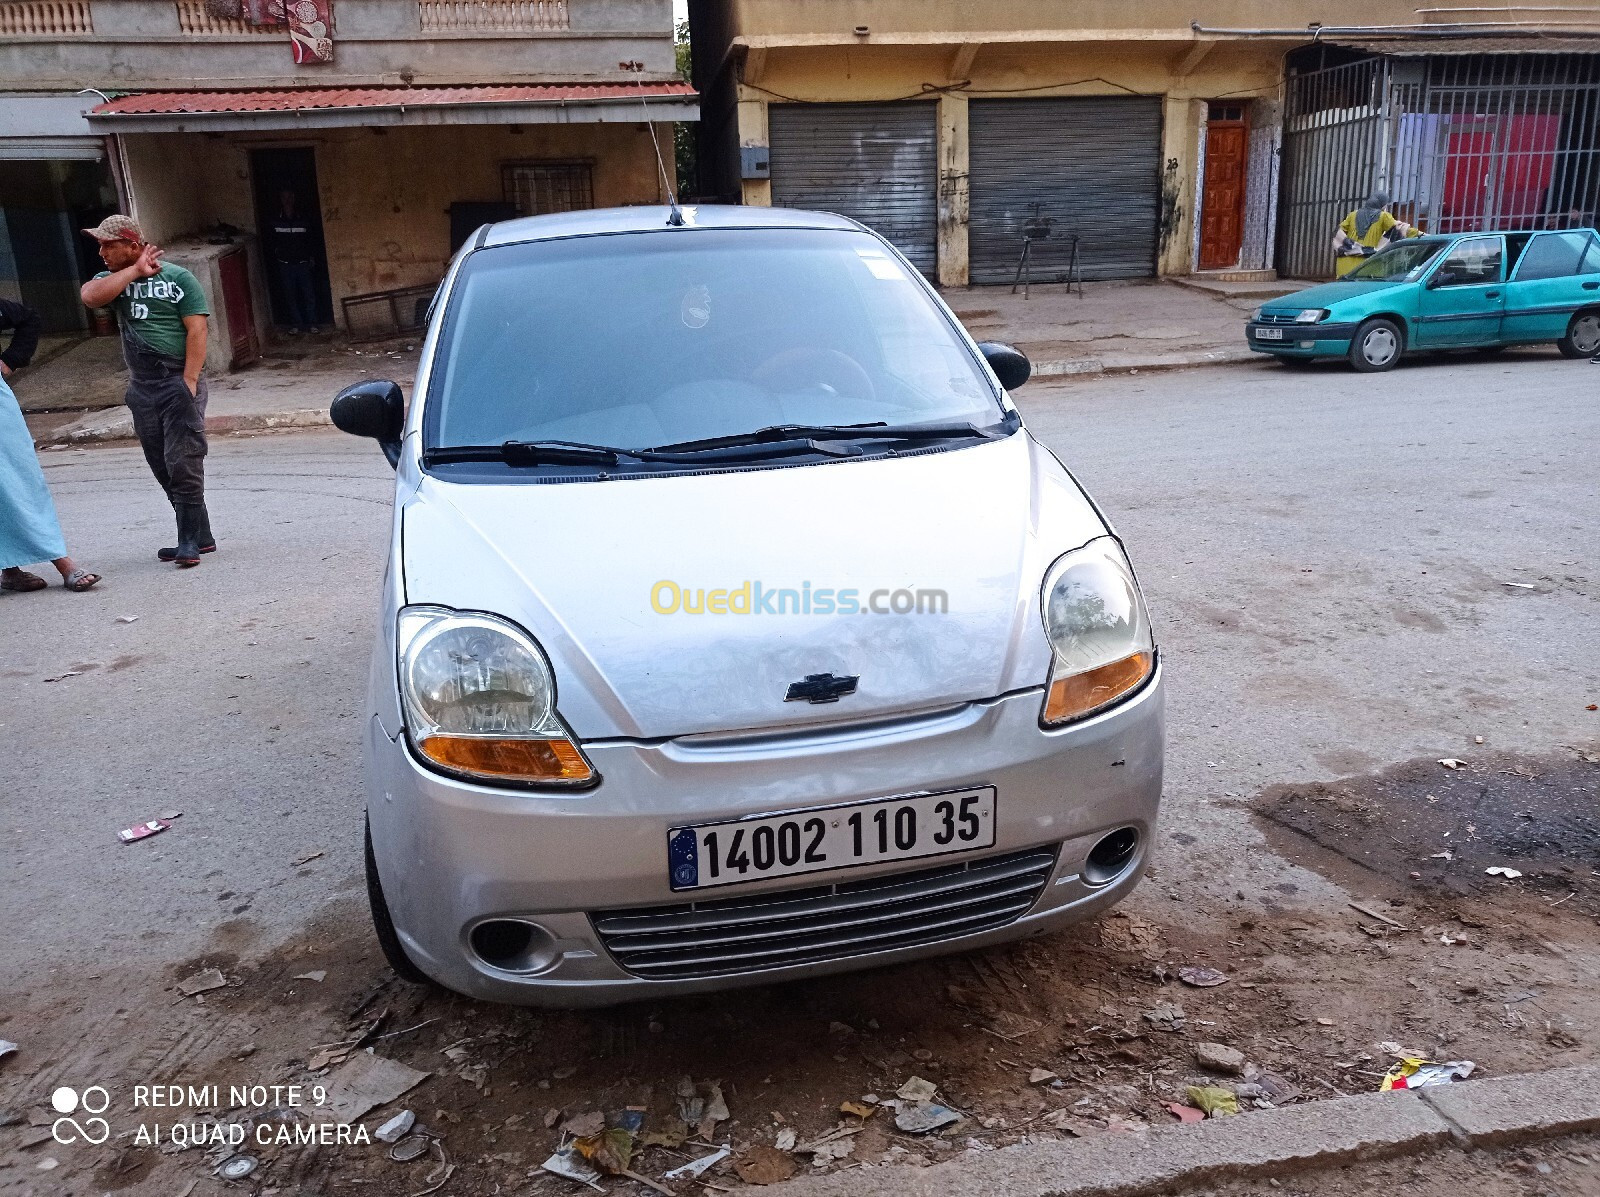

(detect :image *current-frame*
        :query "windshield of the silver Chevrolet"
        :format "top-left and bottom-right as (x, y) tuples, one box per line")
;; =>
(424, 229), (1003, 448)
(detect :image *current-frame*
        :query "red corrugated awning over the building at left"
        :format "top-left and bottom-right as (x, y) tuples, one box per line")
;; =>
(88, 80), (699, 133)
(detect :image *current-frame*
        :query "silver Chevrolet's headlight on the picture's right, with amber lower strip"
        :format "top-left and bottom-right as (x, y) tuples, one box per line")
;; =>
(1042, 536), (1155, 727)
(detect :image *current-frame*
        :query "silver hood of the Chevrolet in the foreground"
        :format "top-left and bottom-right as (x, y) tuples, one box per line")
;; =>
(402, 432), (1106, 739)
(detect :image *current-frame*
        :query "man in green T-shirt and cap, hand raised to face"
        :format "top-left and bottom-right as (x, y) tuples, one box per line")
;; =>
(80, 216), (216, 568)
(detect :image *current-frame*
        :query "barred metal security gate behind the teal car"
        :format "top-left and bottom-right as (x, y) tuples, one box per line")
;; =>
(1278, 54), (1600, 278)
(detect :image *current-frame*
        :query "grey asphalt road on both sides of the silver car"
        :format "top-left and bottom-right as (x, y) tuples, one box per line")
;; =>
(0, 345), (1600, 1039)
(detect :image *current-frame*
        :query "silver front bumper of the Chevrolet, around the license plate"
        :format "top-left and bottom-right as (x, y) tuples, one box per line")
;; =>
(366, 669), (1163, 1007)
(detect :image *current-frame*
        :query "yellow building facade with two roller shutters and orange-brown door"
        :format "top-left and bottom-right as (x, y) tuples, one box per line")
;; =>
(690, 0), (1600, 286)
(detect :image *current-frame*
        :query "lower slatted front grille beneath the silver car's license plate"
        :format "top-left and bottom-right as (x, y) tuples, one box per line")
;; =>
(590, 847), (1056, 981)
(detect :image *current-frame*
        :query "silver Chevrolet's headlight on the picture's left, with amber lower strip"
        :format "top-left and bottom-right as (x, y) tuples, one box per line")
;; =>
(395, 607), (595, 786)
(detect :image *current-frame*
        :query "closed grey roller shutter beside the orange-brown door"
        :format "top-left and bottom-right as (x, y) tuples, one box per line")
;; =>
(970, 96), (1162, 283)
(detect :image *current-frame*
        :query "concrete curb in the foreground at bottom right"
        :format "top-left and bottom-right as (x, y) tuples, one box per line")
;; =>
(768, 1064), (1600, 1197)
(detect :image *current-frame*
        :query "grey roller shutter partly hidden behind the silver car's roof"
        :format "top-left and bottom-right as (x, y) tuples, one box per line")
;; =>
(766, 102), (939, 274)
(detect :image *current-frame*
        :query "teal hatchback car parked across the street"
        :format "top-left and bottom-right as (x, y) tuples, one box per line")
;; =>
(1245, 229), (1600, 371)
